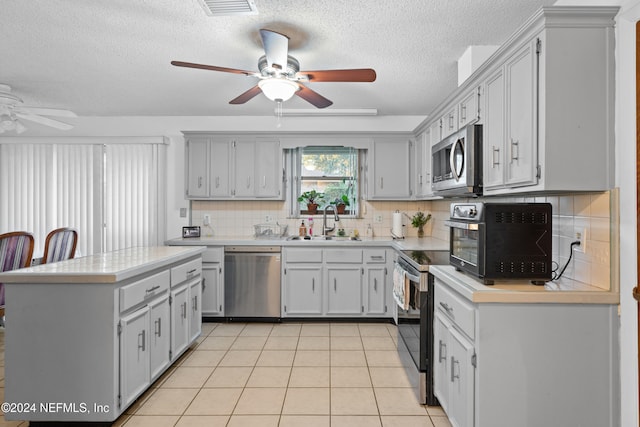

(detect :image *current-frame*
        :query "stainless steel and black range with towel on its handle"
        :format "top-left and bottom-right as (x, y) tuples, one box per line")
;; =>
(396, 250), (449, 405)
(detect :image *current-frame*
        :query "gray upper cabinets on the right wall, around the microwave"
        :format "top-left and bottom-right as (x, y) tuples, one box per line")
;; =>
(417, 6), (618, 195)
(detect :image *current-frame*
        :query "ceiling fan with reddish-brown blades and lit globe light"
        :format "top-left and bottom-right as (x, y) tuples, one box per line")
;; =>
(171, 29), (376, 108)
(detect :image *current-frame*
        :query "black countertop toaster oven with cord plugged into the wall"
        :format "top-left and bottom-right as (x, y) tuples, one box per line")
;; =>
(445, 203), (552, 284)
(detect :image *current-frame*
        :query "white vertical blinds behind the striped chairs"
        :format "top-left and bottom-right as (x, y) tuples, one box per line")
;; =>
(0, 143), (164, 256)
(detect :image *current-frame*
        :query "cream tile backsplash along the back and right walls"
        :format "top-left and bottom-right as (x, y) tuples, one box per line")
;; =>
(191, 191), (618, 289)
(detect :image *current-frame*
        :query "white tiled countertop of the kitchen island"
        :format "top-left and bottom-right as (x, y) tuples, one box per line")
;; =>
(0, 246), (206, 283)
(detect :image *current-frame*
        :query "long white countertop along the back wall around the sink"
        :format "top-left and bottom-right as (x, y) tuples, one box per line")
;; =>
(165, 237), (449, 251)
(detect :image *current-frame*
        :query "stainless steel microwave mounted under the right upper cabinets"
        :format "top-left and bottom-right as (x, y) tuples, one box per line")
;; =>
(431, 125), (482, 196)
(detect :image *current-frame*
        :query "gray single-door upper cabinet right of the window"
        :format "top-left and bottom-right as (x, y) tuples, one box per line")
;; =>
(368, 138), (412, 200)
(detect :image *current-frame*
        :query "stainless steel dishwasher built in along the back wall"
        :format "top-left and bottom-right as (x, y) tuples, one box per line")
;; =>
(224, 246), (281, 319)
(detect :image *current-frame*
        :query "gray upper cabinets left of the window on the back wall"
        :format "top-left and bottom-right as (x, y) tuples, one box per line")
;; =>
(185, 134), (284, 200)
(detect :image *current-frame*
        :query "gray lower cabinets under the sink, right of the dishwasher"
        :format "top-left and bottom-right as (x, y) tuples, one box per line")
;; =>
(282, 247), (391, 317)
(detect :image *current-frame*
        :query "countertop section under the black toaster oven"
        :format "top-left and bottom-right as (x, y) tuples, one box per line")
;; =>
(429, 265), (620, 304)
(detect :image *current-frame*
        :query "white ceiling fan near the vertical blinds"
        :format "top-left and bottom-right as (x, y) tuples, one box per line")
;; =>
(0, 84), (77, 134)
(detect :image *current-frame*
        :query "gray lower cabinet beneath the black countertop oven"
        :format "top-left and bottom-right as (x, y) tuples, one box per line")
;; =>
(432, 269), (619, 427)
